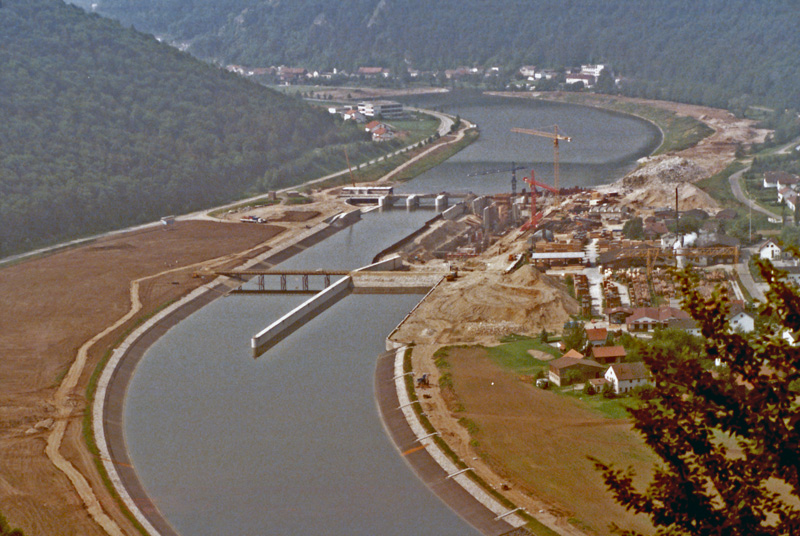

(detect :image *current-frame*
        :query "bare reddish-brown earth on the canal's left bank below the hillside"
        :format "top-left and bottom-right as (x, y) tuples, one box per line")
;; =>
(0, 212), (346, 535)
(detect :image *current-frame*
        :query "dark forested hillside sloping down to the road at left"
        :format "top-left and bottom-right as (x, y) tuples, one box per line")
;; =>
(0, 0), (363, 256)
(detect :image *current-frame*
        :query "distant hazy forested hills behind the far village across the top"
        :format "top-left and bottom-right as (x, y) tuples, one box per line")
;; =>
(72, 0), (800, 108)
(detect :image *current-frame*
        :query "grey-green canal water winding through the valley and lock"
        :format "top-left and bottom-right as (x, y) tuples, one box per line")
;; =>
(124, 90), (658, 536)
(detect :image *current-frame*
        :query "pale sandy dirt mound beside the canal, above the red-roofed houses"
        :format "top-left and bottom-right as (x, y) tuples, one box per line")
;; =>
(394, 266), (578, 344)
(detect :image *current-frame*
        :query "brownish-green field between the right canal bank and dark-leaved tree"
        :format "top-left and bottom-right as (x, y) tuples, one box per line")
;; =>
(441, 344), (654, 534)
